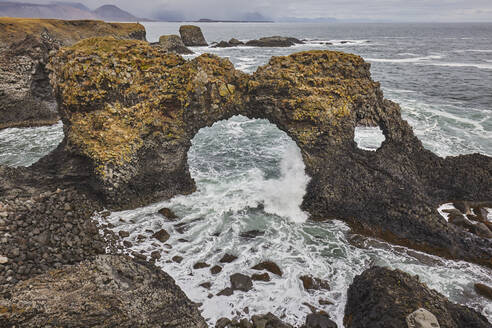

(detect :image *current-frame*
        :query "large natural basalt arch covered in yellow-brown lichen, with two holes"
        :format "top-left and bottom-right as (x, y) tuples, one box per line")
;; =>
(43, 38), (492, 266)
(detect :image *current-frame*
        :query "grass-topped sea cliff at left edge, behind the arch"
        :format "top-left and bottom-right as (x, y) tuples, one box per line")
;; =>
(0, 18), (145, 129)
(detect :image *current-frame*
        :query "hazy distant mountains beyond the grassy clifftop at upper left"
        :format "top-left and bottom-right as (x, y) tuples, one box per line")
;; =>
(0, 1), (147, 22)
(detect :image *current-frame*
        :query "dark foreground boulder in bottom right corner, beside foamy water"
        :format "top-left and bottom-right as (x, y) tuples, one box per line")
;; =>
(344, 267), (491, 328)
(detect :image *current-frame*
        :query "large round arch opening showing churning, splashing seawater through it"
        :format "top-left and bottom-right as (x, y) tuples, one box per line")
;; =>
(188, 115), (309, 222)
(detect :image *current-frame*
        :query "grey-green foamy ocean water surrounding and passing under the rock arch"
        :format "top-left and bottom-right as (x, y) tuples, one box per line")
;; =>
(0, 23), (492, 327)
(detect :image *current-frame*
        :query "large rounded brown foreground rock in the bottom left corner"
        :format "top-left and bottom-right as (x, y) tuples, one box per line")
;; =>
(0, 255), (207, 328)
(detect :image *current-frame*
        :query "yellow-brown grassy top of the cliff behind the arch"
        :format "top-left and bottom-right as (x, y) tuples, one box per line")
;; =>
(0, 17), (145, 45)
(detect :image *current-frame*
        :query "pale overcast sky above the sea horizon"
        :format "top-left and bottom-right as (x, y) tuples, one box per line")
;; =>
(11, 0), (492, 22)
